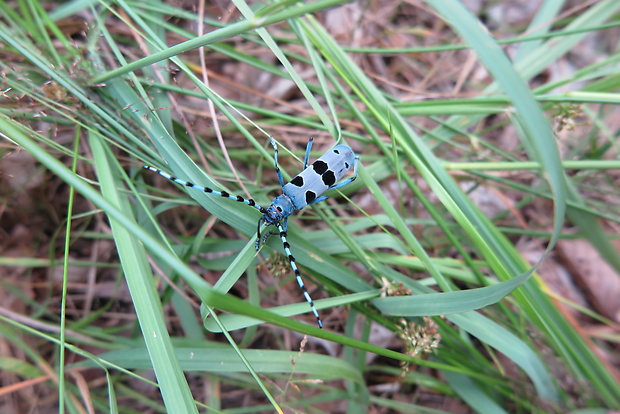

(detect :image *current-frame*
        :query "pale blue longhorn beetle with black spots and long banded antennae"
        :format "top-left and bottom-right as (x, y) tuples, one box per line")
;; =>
(144, 137), (359, 328)
